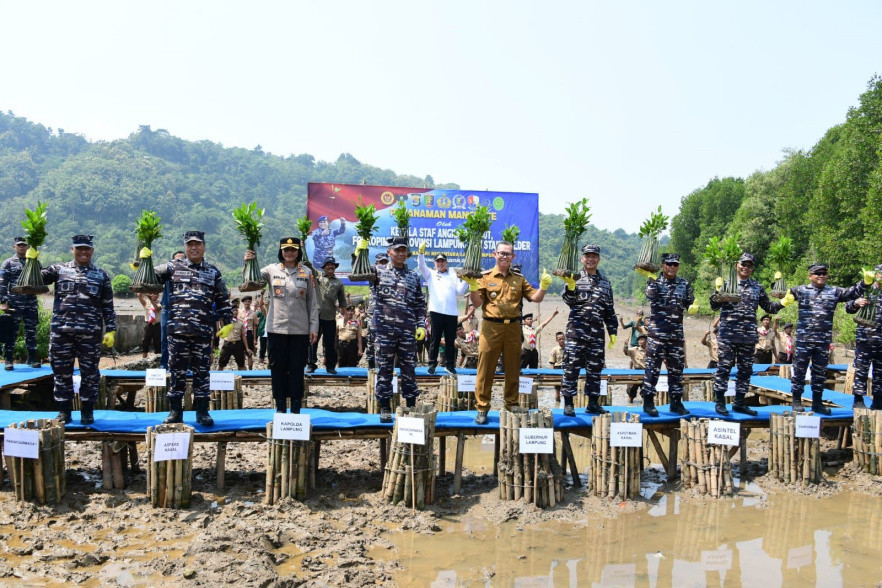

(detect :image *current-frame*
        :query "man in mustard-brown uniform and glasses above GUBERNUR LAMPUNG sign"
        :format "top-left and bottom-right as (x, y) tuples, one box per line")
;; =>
(463, 241), (551, 425)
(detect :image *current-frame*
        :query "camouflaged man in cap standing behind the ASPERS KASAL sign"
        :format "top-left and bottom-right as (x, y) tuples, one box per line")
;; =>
(156, 231), (233, 427)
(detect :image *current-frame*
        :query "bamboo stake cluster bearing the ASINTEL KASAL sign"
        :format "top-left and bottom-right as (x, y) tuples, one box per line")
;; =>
(679, 419), (744, 498)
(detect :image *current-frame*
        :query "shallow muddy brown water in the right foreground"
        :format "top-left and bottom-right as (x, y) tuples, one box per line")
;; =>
(382, 494), (882, 588)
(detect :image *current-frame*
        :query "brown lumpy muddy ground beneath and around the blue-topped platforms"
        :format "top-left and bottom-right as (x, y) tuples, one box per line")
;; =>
(0, 302), (868, 586)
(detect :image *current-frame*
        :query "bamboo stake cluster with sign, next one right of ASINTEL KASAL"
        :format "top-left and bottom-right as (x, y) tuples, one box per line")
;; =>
(769, 412), (821, 484)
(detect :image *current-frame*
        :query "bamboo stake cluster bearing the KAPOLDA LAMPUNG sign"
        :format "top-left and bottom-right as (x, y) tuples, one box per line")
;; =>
(264, 423), (315, 505)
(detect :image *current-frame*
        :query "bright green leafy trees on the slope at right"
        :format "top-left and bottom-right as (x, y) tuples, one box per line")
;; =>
(671, 76), (882, 286)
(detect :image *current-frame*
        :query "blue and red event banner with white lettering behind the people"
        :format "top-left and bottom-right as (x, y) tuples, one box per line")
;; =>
(306, 183), (539, 285)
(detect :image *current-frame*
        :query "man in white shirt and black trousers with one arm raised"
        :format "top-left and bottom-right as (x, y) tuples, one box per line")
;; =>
(417, 243), (469, 375)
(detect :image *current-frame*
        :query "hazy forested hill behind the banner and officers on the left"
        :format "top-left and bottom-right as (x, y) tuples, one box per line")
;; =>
(0, 112), (639, 293)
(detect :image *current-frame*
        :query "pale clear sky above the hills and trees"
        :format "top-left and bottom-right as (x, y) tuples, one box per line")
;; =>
(0, 1), (882, 231)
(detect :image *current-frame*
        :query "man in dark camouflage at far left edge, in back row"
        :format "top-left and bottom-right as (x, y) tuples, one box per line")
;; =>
(0, 237), (40, 370)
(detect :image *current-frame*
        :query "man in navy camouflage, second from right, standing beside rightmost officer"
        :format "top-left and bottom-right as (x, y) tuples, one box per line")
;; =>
(781, 263), (874, 414)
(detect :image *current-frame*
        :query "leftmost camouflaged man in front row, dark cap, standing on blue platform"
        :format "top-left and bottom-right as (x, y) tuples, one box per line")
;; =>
(41, 235), (116, 425)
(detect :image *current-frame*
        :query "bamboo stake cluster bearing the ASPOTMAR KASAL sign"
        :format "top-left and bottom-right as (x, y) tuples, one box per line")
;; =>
(588, 412), (643, 499)
